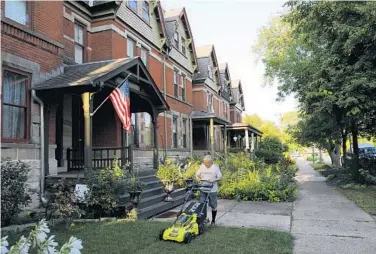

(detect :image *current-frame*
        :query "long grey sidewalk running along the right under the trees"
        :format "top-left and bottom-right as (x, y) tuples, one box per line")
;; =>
(291, 160), (376, 254)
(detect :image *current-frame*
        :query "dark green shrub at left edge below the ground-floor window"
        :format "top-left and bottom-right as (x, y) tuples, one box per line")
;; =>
(1, 158), (31, 226)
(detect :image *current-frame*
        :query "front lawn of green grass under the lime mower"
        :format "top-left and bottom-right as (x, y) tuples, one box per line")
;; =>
(5, 221), (292, 254)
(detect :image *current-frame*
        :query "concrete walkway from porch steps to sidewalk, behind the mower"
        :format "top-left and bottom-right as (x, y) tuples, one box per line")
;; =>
(152, 200), (292, 232)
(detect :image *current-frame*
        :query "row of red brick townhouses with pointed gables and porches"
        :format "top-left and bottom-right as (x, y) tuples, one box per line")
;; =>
(1, 1), (262, 214)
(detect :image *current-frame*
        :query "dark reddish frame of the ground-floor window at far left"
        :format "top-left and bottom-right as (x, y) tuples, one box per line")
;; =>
(1, 65), (31, 144)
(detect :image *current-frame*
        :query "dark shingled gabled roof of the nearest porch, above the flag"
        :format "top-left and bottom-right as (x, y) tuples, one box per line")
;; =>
(32, 57), (169, 111)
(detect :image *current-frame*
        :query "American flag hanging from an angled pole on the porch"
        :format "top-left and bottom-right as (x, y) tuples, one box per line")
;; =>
(110, 80), (132, 133)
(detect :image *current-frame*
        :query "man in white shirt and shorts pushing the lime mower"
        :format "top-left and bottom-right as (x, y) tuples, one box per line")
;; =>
(196, 155), (222, 225)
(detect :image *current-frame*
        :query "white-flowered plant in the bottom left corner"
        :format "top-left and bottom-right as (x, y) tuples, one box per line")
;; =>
(1, 220), (83, 254)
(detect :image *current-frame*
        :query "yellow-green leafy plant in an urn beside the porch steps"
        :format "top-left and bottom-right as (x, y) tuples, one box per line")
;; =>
(157, 159), (181, 201)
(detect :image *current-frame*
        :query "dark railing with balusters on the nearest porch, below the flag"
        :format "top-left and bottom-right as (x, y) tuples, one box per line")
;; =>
(67, 146), (133, 170)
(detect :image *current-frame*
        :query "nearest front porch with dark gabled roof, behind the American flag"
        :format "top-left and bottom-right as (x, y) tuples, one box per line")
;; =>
(34, 57), (169, 176)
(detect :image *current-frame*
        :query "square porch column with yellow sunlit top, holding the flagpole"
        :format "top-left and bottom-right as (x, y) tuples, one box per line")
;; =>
(81, 92), (93, 171)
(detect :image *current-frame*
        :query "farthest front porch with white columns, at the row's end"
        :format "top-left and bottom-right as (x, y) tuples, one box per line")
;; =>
(227, 123), (262, 153)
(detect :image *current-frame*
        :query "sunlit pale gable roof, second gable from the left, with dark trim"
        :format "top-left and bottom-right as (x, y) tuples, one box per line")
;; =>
(164, 8), (198, 66)
